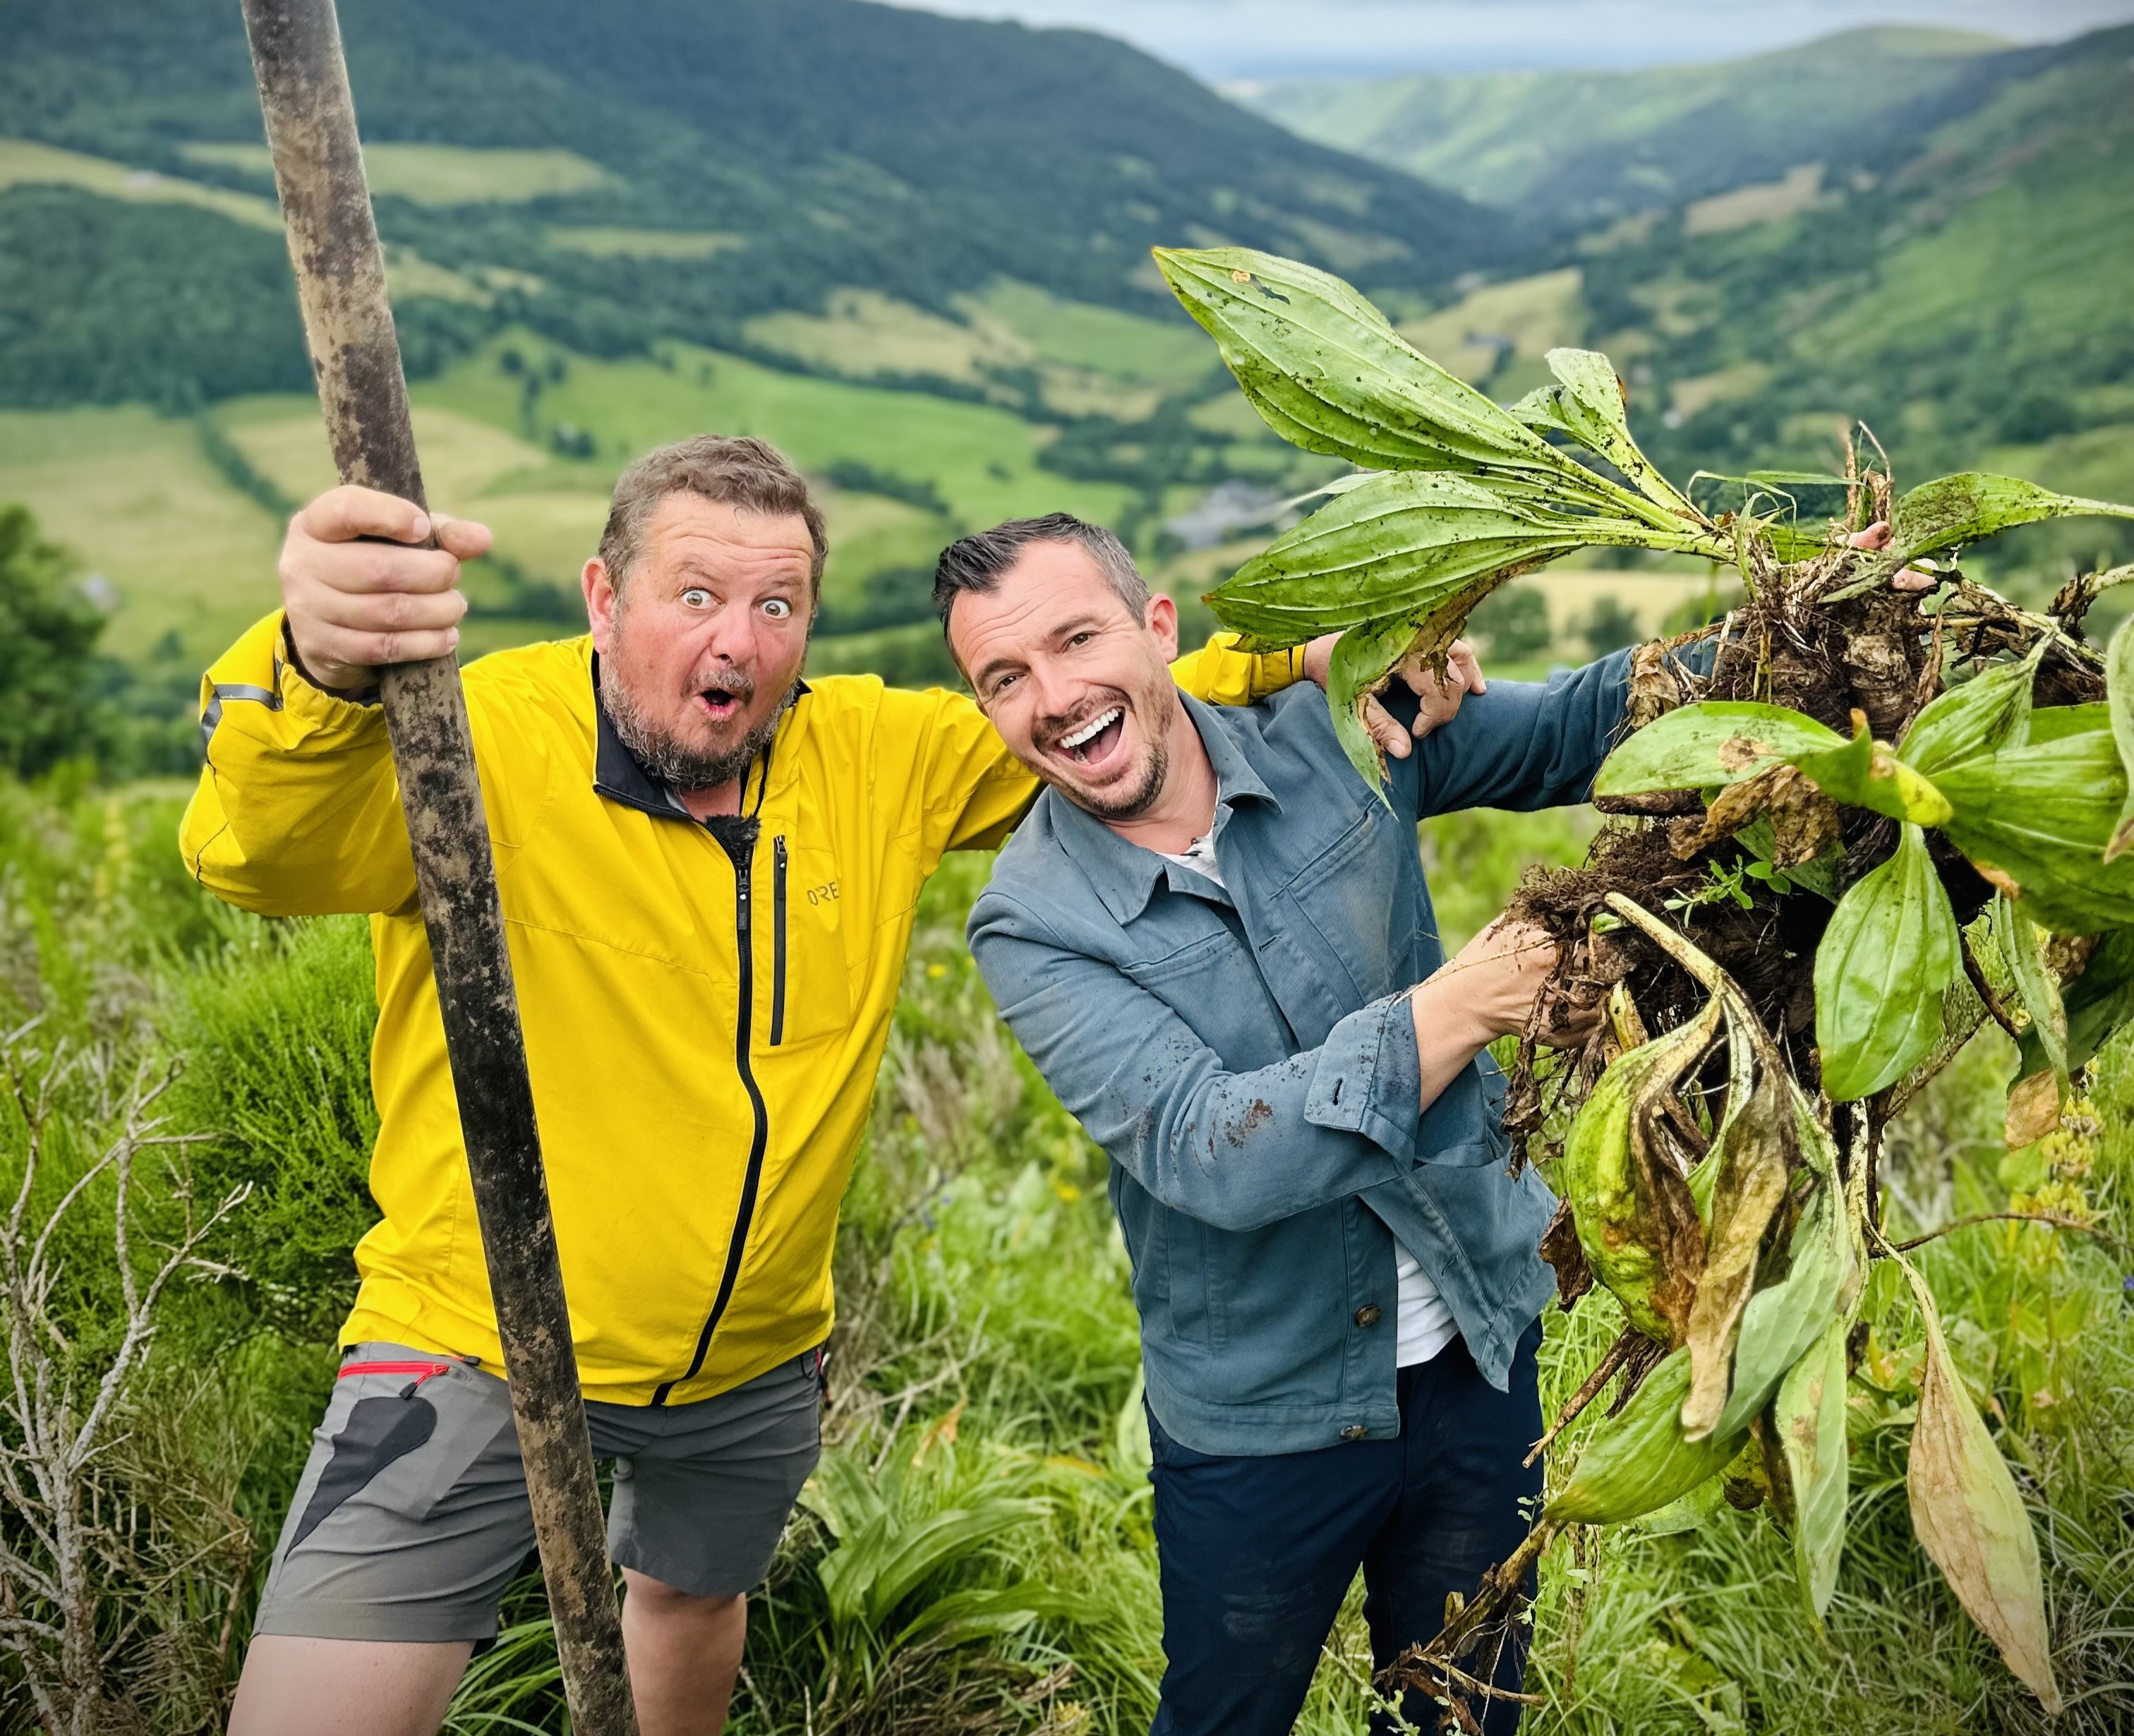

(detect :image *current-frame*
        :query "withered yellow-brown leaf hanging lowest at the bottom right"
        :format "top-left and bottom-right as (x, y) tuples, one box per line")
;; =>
(1895, 1253), (2061, 1713)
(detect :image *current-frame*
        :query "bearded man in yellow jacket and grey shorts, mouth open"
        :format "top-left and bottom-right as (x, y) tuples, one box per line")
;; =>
(183, 438), (1442, 1736)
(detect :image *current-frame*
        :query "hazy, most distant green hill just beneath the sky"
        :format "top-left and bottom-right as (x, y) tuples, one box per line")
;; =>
(1231, 28), (2014, 224)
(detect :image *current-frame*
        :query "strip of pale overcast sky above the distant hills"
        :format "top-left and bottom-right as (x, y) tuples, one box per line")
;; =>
(896, 0), (2134, 79)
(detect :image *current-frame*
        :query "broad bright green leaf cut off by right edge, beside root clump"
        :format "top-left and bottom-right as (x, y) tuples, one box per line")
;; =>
(1934, 721), (2134, 935)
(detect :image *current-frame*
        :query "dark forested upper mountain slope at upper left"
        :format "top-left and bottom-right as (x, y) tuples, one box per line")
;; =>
(0, 0), (1509, 337)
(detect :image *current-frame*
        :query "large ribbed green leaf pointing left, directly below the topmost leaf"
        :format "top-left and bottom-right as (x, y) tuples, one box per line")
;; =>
(1208, 472), (1665, 649)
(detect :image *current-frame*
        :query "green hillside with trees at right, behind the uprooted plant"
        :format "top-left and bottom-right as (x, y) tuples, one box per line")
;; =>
(1263, 30), (2134, 617)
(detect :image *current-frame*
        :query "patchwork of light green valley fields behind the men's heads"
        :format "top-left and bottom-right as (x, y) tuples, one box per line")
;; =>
(0, 313), (1332, 677)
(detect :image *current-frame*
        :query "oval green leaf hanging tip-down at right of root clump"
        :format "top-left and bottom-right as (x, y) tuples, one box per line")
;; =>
(1816, 824), (1963, 1102)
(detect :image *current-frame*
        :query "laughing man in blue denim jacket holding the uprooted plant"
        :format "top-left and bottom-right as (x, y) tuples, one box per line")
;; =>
(935, 514), (1628, 1736)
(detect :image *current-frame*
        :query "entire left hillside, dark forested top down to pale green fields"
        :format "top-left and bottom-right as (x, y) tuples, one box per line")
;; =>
(0, 0), (1513, 692)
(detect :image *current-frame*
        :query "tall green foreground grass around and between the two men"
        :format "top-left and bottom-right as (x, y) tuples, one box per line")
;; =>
(0, 783), (2134, 1736)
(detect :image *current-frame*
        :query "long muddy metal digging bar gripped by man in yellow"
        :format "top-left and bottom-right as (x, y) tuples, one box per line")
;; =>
(243, 0), (638, 1736)
